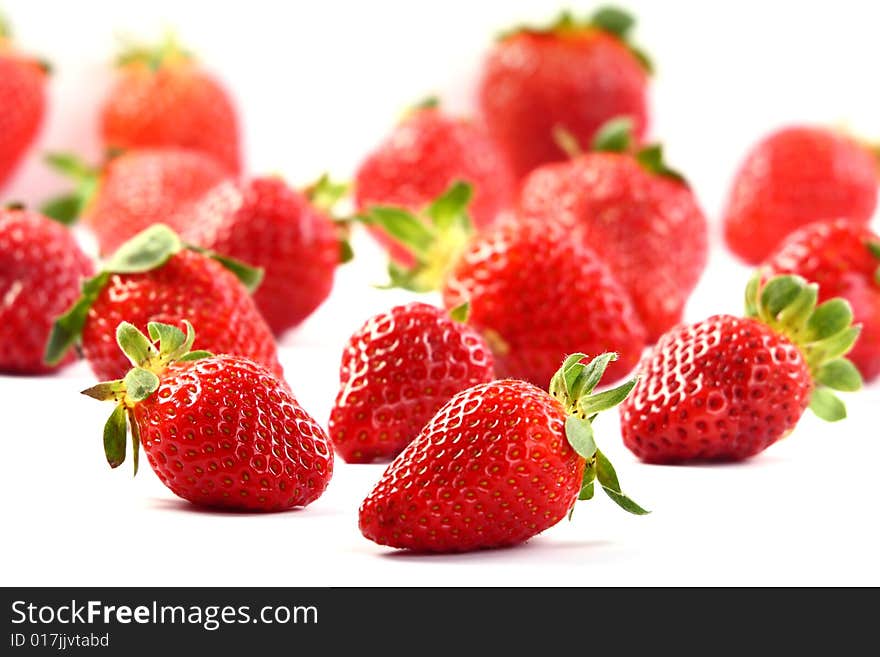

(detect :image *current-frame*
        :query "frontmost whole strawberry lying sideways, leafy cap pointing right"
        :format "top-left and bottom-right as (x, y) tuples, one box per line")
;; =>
(359, 354), (647, 552)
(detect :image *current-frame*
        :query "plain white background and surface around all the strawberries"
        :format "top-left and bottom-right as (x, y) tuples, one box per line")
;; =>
(0, 0), (880, 586)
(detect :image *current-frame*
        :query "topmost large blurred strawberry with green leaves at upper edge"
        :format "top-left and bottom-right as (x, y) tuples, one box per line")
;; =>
(479, 7), (650, 178)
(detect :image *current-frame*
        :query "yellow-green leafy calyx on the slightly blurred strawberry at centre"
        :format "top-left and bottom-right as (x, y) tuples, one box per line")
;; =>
(356, 181), (473, 292)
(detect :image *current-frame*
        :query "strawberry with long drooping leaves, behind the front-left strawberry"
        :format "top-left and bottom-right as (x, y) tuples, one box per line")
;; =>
(46, 224), (282, 379)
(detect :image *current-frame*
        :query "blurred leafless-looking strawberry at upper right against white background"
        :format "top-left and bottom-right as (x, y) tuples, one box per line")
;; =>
(724, 127), (877, 264)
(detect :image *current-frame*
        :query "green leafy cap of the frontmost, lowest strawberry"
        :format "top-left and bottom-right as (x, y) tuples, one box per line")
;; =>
(550, 353), (649, 518)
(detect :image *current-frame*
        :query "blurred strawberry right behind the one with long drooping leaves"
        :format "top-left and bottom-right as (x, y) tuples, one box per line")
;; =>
(179, 178), (343, 334)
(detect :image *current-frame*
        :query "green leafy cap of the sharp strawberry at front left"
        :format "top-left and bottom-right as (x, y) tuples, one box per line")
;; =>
(82, 320), (212, 474)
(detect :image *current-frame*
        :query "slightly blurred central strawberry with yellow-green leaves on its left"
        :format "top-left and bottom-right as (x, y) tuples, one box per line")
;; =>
(366, 183), (645, 383)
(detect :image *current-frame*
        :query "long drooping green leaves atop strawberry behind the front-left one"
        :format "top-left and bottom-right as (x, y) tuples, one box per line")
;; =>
(43, 224), (263, 365)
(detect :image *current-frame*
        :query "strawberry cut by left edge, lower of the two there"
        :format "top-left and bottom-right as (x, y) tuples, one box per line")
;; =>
(0, 207), (92, 374)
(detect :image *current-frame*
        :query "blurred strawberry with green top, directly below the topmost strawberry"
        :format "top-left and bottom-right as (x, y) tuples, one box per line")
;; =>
(520, 119), (708, 342)
